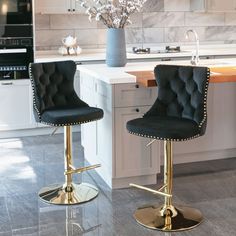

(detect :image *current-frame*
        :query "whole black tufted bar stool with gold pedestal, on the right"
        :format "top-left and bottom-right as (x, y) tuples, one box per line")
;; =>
(127, 65), (210, 231)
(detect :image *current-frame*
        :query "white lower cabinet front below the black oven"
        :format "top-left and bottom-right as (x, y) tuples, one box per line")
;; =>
(0, 80), (35, 130)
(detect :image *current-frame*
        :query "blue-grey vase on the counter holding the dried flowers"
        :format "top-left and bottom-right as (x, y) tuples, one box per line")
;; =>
(106, 28), (127, 67)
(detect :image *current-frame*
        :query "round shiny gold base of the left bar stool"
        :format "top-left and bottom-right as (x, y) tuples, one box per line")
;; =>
(39, 183), (98, 205)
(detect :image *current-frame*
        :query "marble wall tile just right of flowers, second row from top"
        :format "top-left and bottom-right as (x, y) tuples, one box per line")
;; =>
(143, 12), (184, 28)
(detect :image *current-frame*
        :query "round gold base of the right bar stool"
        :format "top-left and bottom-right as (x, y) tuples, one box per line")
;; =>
(134, 206), (203, 232)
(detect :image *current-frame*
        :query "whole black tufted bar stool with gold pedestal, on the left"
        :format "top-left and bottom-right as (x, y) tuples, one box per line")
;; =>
(29, 61), (103, 204)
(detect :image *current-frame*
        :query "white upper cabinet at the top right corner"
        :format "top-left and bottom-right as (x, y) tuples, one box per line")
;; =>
(190, 0), (236, 12)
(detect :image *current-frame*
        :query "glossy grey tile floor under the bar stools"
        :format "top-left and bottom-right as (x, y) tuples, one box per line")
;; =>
(0, 133), (236, 236)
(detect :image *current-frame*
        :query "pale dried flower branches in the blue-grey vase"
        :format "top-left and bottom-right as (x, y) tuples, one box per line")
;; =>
(79, 0), (147, 28)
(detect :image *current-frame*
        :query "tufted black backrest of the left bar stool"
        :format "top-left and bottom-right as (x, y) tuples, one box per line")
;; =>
(29, 61), (88, 120)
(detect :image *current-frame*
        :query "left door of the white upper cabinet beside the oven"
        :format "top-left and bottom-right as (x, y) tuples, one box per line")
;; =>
(35, 0), (71, 14)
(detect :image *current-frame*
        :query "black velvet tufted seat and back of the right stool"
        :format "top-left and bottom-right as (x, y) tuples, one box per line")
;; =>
(127, 65), (210, 141)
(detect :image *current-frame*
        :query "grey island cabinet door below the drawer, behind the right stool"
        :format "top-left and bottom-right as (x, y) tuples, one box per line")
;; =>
(115, 106), (160, 177)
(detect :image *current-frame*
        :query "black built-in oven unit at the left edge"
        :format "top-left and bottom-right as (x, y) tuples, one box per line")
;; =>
(0, 0), (34, 80)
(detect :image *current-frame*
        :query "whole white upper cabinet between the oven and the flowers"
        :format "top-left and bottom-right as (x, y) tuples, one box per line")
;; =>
(35, 0), (84, 14)
